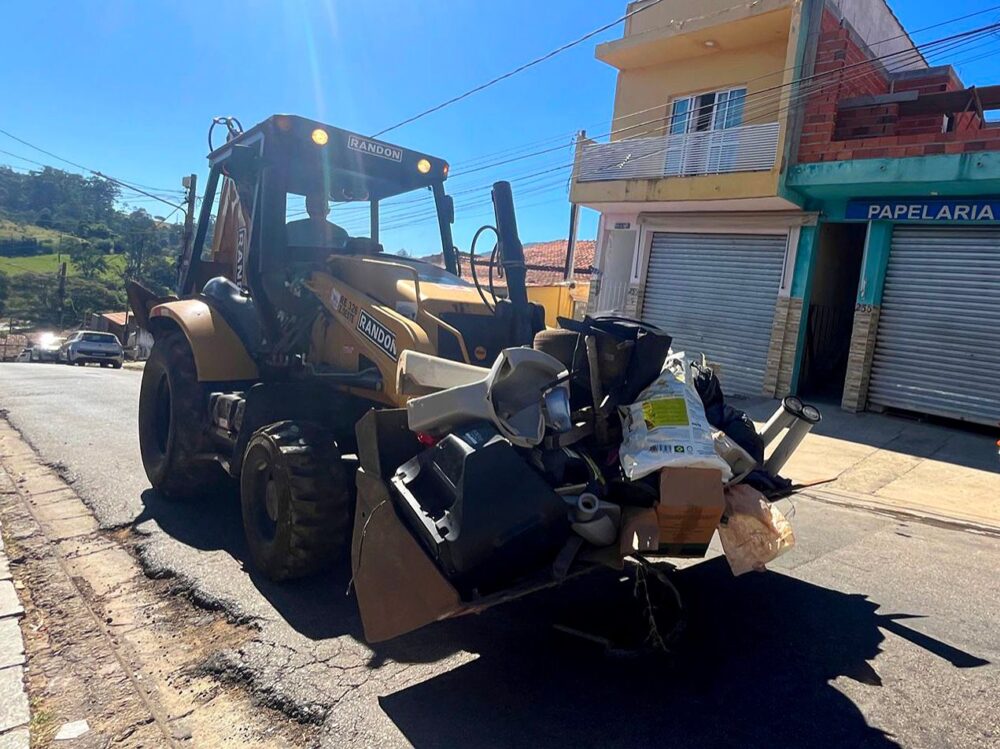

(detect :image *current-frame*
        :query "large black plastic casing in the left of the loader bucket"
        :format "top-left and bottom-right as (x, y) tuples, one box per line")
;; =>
(392, 423), (569, 596)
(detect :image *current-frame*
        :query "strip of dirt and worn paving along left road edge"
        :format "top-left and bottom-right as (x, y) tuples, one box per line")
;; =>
(0, 423), (315, 748)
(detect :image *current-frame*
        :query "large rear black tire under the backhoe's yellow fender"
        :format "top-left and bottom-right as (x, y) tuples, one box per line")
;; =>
(139, 330), (229, 499)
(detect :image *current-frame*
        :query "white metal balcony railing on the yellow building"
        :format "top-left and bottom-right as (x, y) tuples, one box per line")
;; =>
(576, 122), (781, 182)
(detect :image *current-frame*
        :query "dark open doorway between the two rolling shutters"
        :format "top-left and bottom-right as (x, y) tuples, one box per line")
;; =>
(799, 223), (868, 403)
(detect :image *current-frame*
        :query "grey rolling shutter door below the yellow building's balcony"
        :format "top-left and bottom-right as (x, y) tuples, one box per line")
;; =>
(642, 232), (788, 395)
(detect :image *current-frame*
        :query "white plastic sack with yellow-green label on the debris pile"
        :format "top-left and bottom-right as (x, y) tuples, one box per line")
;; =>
(618, 353), (733, 481)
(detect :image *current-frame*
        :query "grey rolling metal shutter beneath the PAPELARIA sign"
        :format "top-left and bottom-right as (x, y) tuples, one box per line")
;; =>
(868, 227), (1000, 424)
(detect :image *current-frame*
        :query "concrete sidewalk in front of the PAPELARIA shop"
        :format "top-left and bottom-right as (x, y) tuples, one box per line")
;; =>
(732, 399), (1000, 532)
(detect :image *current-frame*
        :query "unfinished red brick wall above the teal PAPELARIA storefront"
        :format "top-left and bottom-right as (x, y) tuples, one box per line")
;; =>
(798, 9), (1000, 163)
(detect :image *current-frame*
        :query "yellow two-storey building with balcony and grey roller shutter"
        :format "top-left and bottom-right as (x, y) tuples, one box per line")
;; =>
(571, 0), (816, 395)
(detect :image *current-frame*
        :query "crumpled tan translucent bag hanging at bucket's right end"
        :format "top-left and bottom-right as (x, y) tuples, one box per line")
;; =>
(719, 484), (795, 576)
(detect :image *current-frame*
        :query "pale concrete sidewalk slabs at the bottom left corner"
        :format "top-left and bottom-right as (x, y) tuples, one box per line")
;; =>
(0, 516), (31, 749)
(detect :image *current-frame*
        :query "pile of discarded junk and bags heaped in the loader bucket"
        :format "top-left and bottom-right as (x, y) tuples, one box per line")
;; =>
(355, 317), (819, 640)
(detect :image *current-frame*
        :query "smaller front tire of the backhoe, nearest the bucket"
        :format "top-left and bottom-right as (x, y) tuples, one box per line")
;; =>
(240, 421), (355, 581)
